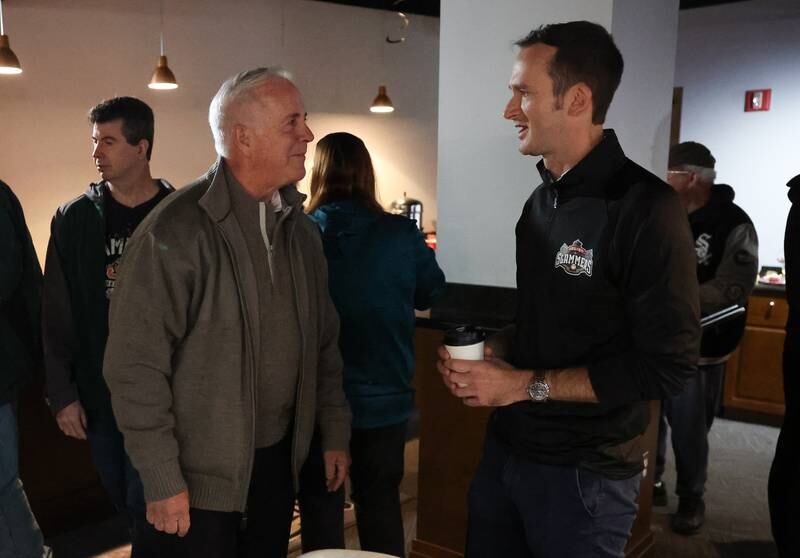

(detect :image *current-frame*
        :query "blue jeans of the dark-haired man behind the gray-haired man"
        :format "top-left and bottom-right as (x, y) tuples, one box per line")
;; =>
(86, 423), (155, 558)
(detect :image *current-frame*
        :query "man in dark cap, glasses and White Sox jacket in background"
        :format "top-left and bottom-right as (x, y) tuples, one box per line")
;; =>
(653, 141), (758, 535)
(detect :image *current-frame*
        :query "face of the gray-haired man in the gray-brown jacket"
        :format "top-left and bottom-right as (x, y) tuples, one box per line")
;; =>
(238, 79), (314, 188)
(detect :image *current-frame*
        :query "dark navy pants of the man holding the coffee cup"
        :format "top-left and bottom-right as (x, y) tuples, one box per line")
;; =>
(465, 433), (641, 558)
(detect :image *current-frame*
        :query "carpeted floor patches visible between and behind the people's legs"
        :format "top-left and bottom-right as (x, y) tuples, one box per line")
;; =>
(49, 419), (778, 558)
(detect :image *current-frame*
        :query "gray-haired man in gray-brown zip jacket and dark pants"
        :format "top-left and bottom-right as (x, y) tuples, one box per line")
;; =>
(104, 68), (350, 558)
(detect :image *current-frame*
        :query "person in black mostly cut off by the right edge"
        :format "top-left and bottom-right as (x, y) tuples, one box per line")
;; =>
(769, 175), (800, 558)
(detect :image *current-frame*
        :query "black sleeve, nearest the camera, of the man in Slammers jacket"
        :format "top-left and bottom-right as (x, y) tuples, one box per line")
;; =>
(588, 191), (700, 406)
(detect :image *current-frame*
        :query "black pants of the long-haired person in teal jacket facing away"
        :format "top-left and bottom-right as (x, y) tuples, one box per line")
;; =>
(300, 422), (406, 556)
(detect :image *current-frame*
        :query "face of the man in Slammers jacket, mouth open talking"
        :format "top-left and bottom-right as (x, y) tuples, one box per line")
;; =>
(503, 44), (566, 157)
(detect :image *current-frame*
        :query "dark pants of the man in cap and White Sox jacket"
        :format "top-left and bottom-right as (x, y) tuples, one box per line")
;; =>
(655, 363), (725, 498)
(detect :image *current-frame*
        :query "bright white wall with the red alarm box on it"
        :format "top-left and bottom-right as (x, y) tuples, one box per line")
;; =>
(675, 0), (800, 272)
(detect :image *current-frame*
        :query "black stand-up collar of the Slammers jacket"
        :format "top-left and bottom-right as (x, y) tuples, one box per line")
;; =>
(536, 129), (626, 194)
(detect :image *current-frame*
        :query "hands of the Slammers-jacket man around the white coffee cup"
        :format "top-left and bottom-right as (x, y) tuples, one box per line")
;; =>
(436, 347), (533, 407)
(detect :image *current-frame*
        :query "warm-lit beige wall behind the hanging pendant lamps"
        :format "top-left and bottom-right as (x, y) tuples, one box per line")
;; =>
(0, 0), (439, 259)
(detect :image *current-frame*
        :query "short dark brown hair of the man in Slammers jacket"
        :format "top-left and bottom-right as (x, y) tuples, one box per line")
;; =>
(514, 21), (624, 124)
